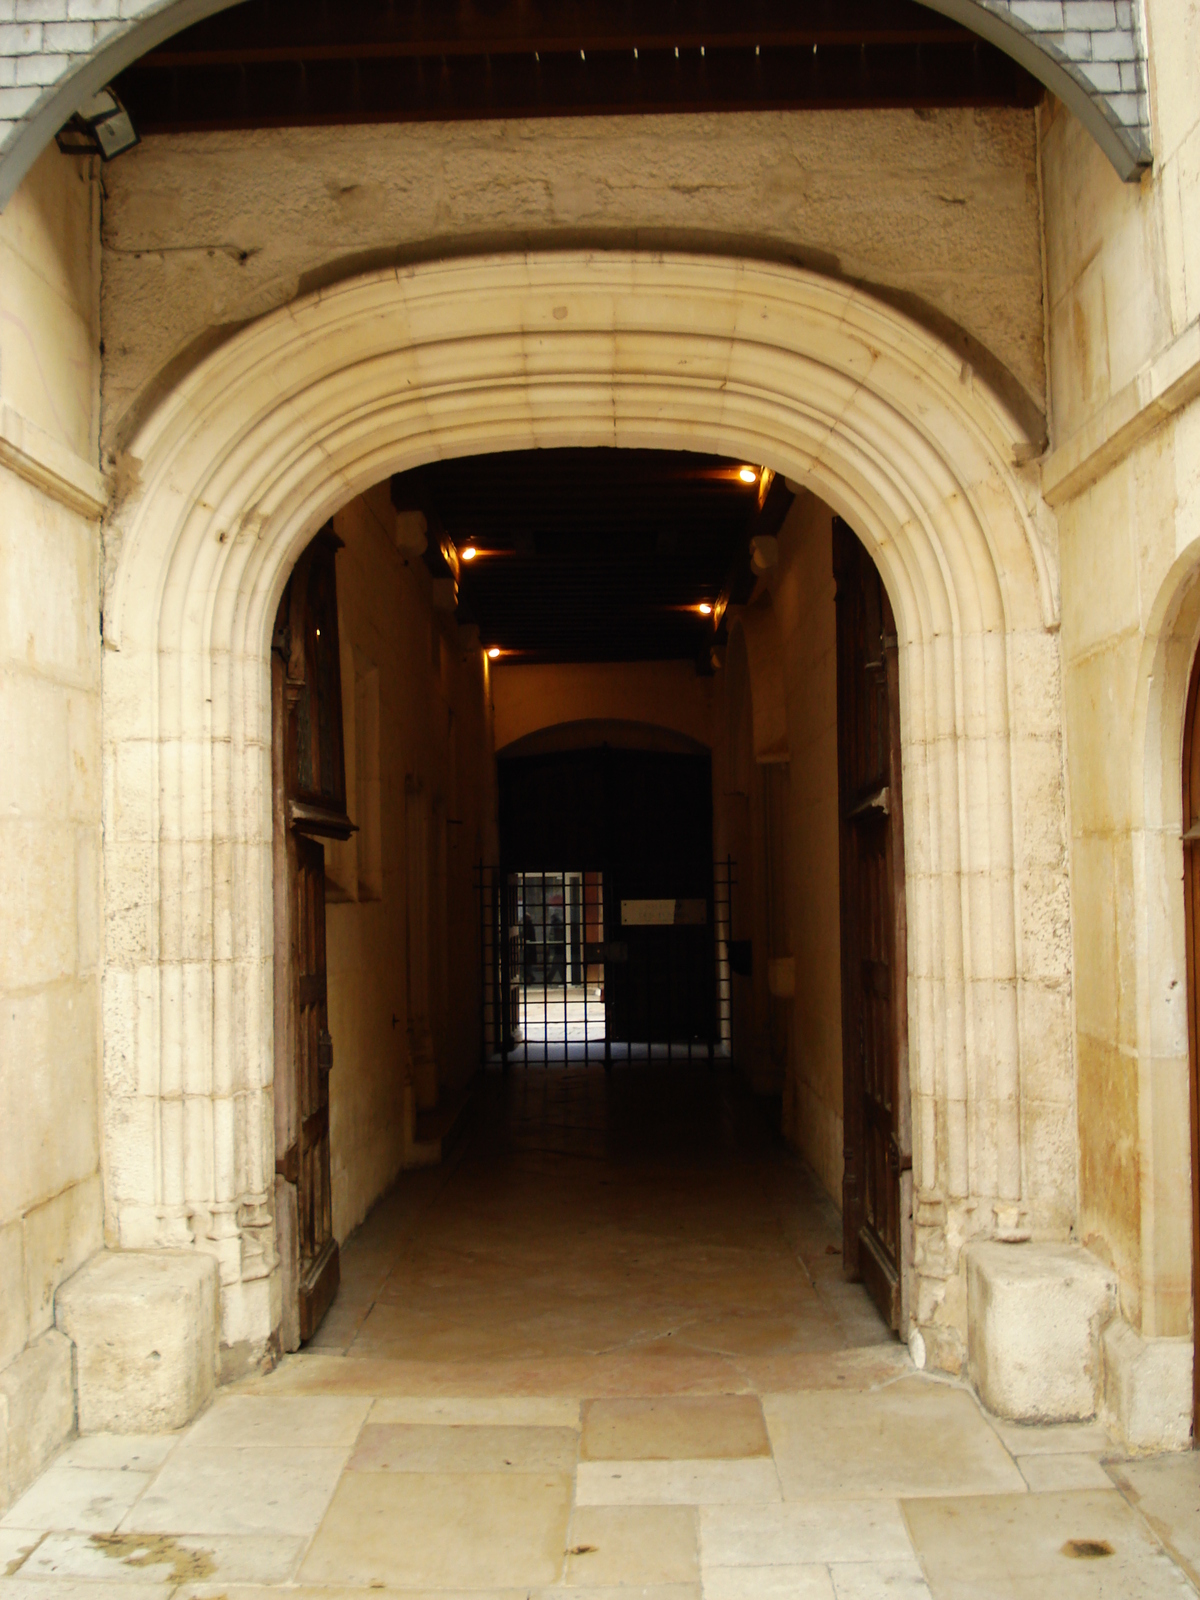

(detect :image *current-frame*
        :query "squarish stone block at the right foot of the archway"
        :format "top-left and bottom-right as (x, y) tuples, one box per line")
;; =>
(966, 1242), (1117, 1422)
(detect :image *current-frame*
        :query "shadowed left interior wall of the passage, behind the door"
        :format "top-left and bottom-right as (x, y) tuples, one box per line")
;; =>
(326, 485), (494, 1238)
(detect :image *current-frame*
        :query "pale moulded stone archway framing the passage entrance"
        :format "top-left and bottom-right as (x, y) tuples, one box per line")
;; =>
(104, 253), (1075, 1365)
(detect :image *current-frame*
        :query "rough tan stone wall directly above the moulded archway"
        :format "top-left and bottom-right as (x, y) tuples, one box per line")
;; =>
(96, 110), (1045, 467)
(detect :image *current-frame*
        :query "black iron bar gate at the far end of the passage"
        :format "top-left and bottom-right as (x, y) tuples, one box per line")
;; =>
(478, 858), (734, 1066)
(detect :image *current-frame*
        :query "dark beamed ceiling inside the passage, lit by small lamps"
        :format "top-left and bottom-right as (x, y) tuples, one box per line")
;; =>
(392, 450), (792, 670)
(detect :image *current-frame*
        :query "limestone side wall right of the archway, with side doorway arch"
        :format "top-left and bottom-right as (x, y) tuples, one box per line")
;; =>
(1042, 0), (1200, 1405)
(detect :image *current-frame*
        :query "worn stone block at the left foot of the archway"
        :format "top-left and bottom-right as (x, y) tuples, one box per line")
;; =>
(54, 1250), (221, 1434)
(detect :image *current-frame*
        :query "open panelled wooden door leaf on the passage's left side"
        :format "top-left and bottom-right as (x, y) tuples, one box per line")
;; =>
(272, 531), (354, 1349)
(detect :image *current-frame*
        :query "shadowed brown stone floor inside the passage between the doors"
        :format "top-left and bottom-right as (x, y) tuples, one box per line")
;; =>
(310, 1064), (890, 1369)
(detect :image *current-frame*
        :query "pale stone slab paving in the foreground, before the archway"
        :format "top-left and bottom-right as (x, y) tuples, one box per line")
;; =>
(0, 1352), (1200, 1600)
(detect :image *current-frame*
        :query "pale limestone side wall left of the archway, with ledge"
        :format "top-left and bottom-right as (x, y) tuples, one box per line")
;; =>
(0, 150), (104, 1507)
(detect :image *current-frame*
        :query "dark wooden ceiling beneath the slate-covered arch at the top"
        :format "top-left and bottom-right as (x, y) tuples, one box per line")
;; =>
(117, 0), (1042, 133)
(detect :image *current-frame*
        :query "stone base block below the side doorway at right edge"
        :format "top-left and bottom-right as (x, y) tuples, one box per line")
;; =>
(1104, 1317), (1192, 1450)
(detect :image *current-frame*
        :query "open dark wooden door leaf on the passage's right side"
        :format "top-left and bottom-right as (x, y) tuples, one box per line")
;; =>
(834, 520), (912, 1330)
